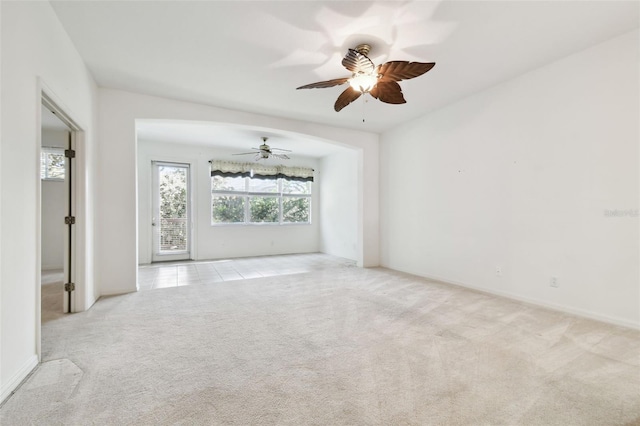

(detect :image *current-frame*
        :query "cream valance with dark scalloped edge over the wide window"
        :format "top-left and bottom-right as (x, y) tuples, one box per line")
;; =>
(209, 160), (313, 182)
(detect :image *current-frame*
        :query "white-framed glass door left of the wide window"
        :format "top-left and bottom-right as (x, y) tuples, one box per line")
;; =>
(151, 161), (191, 262)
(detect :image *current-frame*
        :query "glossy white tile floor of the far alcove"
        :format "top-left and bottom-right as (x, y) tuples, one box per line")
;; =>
(138, 253), (355, 291)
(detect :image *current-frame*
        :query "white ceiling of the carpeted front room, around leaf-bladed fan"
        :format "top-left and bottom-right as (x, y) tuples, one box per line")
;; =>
(51, 0), (639, 156)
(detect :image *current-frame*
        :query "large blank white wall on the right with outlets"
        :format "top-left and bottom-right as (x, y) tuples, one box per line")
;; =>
(381, 31), (640, 327)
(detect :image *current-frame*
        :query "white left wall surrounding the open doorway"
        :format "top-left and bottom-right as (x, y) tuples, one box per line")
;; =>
(0, 2), (96, 400)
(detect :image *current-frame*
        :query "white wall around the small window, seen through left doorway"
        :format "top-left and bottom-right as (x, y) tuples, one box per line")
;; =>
(40, 129), (69, 269)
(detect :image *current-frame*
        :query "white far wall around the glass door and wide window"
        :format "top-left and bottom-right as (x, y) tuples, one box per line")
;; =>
(138, 140), (319, 263)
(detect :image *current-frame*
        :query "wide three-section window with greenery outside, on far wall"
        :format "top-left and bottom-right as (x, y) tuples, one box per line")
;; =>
(211, 163), (313, 225)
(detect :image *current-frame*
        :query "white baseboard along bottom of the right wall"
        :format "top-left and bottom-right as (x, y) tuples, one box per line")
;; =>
(387, 268), (640, 330)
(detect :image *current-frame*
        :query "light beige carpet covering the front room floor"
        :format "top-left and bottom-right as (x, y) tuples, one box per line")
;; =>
(0, 258), (640, 426)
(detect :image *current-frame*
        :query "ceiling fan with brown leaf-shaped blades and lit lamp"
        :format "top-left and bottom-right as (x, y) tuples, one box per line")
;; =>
(297, 44), (436, 112)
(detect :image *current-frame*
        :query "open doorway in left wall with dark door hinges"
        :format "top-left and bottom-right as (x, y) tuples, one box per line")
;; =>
(34, 90), (86, 361)
